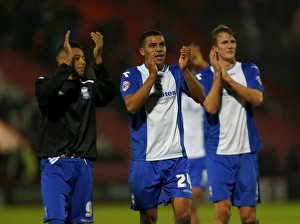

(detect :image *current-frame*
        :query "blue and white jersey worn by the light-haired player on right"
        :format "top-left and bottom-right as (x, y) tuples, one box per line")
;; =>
(196, 62), (263, 155)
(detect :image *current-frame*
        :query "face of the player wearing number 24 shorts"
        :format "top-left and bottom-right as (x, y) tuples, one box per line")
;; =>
(140, 36), (167, 67)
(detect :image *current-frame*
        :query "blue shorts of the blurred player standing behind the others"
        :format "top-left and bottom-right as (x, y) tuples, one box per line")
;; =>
(189, 157), (207, 190)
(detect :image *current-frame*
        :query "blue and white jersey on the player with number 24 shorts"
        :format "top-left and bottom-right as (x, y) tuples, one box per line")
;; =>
(120, 64), (188, 161)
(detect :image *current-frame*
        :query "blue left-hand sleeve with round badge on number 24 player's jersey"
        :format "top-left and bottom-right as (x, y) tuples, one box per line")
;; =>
(120, 67), (142, 99)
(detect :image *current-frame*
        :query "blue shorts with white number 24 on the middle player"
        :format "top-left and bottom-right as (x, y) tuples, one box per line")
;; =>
(129, 157), (192, 211)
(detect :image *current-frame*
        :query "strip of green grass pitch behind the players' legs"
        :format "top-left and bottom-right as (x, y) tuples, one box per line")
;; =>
(0, 202), (300, 224)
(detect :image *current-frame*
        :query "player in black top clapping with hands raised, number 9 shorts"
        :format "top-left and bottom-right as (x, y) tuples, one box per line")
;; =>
(35, 31), (115, 224)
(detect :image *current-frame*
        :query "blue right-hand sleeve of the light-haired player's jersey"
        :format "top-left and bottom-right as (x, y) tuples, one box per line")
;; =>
(242, 63), (263, 92)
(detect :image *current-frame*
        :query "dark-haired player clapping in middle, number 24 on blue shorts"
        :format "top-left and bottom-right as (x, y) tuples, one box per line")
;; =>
(120, 30), (205, 224)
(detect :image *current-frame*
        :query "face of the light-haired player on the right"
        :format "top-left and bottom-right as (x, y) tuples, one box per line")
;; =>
(215, 32), (236, 61)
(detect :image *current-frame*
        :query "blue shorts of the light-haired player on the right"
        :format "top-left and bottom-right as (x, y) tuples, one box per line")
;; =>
(206, 152), (260, 206)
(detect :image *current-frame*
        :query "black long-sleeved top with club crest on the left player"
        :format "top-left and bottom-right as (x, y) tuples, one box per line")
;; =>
(35, 64), (115, 161)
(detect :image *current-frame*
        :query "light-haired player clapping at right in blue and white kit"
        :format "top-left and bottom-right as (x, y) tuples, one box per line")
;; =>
(196, 25), (263, 224)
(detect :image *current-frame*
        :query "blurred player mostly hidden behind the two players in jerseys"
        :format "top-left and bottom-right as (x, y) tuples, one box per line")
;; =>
(181, 43), (209, 224)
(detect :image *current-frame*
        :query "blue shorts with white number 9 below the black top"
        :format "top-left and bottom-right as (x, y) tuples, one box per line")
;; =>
(41, 158), (94, 223)
